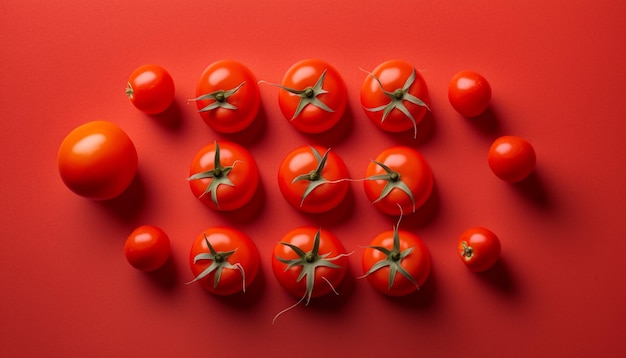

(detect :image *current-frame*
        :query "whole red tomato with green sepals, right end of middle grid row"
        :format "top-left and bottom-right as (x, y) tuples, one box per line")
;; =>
(363, 146), (434, 215)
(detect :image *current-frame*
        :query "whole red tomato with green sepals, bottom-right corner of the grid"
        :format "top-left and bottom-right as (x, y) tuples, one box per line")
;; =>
(363, 226), (431, 296)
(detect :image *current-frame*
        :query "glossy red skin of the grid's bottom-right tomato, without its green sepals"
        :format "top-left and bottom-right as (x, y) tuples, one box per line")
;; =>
(362, 230), (432, 297)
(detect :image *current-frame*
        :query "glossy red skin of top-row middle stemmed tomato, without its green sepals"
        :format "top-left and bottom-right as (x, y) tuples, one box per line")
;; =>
(278, 59), (348, 134)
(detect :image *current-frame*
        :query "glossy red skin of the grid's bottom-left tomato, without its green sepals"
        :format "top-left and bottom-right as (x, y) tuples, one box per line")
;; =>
(189, 226), (261, 296)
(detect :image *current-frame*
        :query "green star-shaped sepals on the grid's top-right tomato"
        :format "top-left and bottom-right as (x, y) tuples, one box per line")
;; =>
(364, 69), (430, 138)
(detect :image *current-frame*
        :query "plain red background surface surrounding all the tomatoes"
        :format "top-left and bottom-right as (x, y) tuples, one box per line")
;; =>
(0, 0), (626, 357)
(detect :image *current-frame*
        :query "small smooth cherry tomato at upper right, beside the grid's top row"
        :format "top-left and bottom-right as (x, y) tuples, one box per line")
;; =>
(448, 71), (491, 117)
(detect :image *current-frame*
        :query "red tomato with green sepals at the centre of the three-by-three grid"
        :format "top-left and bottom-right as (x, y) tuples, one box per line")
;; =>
(278, 146), (348, 213)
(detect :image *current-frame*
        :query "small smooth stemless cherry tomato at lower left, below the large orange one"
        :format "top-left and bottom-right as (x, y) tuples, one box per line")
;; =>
(124, 225), (170, 272)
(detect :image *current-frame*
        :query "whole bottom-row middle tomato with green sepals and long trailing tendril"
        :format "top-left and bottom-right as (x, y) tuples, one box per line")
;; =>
(272, 227), (349, 321)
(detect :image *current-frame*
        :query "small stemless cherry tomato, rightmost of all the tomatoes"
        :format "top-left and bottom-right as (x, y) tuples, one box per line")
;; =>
(487, 136), (537, 183)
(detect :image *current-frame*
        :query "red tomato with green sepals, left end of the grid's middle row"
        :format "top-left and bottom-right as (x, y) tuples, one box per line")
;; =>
(189, 141), (259, 211)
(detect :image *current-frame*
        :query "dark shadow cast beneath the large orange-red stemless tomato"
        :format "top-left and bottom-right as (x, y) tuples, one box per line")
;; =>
(95, 171), (146, 223)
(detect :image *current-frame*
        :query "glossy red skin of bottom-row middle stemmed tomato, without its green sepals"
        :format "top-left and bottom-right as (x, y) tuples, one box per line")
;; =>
(272, 227), (348, 298)
